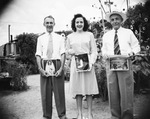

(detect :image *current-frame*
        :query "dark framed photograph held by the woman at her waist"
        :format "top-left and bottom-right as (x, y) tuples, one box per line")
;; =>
(75, 54), (91, 72)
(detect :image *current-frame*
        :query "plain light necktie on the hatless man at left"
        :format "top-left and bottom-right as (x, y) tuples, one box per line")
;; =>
(47, 34), (53, 59)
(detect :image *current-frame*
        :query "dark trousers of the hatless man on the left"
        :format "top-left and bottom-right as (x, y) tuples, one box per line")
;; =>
(40, 60), (66, 119)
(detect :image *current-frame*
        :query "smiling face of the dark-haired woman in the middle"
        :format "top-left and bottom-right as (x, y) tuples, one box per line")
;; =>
(75, 17), (84, 31)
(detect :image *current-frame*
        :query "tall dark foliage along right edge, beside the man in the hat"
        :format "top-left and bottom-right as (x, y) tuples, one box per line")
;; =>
(124, 1), (150, 92)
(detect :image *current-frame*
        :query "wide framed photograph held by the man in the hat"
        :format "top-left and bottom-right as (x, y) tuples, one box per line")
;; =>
(110, 56), (129, 71)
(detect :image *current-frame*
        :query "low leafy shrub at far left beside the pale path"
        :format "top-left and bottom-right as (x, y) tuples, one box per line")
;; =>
(6, 61), (29, 91)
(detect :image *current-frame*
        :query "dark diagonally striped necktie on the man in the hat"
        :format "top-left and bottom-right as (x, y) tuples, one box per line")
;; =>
(114, 30), (121, 55)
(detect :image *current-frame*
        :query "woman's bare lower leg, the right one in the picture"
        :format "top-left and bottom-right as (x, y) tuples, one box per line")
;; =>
(86, 95), (93, 119)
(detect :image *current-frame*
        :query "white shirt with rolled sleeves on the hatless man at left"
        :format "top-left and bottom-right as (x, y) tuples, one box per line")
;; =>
(35, 33), (65, 59)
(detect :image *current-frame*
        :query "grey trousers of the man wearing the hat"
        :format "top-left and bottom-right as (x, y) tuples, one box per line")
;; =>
(106, 59), (134, 119)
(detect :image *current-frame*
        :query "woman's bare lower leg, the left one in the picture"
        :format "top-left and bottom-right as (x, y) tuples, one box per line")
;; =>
(76, 95), (83, 119)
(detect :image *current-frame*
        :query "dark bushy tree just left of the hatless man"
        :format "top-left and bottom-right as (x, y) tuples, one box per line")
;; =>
(16, 33), (38, 73)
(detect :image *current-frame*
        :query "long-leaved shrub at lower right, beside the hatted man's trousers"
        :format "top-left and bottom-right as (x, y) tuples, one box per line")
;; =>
(132, 53), (150, 93)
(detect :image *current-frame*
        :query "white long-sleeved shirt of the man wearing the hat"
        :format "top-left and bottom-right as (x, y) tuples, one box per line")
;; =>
(102, 27), (140, 55)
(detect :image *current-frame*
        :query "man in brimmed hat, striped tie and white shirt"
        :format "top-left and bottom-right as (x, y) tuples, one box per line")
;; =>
(102, 12), (140, 119)
